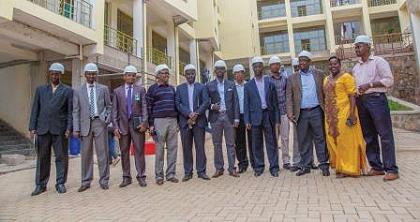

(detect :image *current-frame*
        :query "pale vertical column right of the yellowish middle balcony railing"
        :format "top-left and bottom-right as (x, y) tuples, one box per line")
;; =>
(133, 0), (144, 58)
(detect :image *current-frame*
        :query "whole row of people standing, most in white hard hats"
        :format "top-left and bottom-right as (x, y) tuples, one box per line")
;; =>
(29, 36), (398, 195)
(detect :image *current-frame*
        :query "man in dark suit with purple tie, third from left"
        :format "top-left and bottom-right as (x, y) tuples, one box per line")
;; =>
(112, 65), (148, 187)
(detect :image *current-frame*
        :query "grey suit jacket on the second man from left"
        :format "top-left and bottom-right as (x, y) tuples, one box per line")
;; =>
(73, 82), (112, 136)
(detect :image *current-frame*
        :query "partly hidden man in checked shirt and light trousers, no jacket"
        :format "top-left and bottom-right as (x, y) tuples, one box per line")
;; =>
(268, 56), (300, 172)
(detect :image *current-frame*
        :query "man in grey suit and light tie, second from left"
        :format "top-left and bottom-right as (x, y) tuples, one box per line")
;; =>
(73, 63), (111, 192)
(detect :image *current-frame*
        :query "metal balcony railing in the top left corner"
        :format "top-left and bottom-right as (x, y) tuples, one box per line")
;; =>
(28, 0), (93, 28)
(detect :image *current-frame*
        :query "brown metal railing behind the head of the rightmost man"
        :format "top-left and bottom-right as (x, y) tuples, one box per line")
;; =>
(336, 33), (414, 59)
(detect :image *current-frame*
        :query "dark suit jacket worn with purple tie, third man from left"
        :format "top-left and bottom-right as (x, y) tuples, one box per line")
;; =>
(112, 84), (149, 135)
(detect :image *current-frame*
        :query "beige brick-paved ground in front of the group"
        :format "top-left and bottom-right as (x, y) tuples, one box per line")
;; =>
(0, 130), (420, 222)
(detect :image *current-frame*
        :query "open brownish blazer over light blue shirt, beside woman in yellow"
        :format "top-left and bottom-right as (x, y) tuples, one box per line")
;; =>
(286, 69), (324, 121)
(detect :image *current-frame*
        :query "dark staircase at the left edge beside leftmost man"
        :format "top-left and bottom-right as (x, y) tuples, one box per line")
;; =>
(0, 119), (34, 156)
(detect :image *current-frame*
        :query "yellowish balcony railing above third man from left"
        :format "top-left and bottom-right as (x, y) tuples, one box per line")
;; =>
(104, 25), (140, 56)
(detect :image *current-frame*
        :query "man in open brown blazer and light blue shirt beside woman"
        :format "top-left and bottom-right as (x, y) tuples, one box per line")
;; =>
(286, 50), (330, 176)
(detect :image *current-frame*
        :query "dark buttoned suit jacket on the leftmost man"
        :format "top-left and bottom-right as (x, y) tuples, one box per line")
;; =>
(28, 83), (73, 135)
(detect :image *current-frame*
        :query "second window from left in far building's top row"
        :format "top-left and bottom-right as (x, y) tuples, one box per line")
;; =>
(290, 0), (322, 17)
